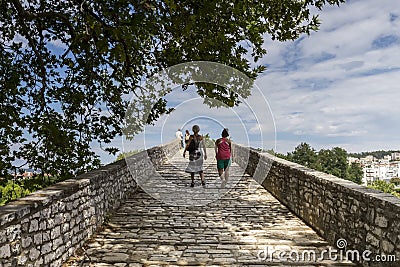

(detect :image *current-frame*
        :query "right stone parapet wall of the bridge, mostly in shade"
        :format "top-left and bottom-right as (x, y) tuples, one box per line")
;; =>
(233, 144), (400, 266)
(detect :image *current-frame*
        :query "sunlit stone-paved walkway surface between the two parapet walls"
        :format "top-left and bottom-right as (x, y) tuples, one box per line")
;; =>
(64, 151), (356, 267)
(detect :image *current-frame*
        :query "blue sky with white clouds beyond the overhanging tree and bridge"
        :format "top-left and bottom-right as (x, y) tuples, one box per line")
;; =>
(101, 0), (400, 163)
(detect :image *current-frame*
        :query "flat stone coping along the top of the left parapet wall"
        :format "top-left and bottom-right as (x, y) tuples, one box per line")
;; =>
(0, 140), (176, 227)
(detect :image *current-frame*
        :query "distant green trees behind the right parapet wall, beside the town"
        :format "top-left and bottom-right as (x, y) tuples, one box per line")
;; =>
(275, 143), (363, 184)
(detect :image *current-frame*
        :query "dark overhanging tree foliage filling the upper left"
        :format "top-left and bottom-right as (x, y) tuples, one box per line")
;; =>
(0, 0), (344, 180)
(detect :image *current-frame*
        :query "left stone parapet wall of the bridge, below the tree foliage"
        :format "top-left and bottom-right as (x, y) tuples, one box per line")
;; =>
(0, 141), (179, 267)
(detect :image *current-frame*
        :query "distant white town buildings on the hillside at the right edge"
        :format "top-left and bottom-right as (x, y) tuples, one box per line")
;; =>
(347, 152), (400, 185)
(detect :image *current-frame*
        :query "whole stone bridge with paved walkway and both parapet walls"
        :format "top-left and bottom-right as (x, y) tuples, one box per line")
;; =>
(0, 142), (400, 266)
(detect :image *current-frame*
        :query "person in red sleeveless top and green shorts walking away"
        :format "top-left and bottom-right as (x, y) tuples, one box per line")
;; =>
(215, 128), (232, 182)
